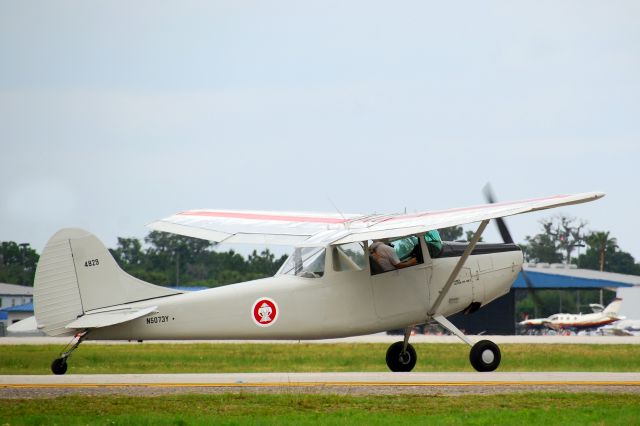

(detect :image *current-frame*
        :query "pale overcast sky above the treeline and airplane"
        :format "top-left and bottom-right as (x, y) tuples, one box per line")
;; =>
(0, 0), (640, 261)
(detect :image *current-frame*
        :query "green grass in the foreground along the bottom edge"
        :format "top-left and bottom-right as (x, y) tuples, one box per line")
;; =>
(0, 393), (640, 426)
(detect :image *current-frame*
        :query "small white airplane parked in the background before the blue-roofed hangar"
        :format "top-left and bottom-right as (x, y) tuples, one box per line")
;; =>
(519, 298), (622, 331)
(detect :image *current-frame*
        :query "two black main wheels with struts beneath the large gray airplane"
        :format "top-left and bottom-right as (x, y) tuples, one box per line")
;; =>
(387, 315), (502, 372)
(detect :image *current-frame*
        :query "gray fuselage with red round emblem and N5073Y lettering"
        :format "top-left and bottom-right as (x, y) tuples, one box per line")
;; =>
(87, 243), (523, 340)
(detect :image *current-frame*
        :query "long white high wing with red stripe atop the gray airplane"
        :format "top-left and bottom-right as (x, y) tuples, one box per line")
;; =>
(147, 192), (605, 246)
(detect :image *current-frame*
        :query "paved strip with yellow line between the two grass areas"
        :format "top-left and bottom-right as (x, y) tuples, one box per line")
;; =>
(0, 372), (640, 398)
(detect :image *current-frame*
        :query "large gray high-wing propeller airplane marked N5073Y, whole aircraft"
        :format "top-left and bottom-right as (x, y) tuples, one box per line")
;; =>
(34, 192), (605, 374)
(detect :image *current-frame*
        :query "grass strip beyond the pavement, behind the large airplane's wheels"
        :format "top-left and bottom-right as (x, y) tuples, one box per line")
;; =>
(0, 343), (640, 374)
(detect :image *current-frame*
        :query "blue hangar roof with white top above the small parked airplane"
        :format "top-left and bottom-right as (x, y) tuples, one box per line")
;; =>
(512, 265), (640, 289)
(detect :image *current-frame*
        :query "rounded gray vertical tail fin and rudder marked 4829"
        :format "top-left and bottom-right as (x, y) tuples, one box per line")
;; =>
(34, 229), (178, 336)
